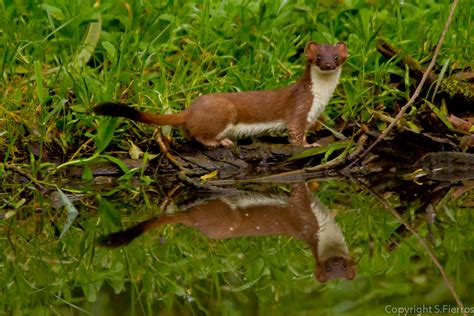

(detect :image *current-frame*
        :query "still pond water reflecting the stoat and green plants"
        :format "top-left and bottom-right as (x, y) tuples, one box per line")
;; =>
(0, 159), (474, 315)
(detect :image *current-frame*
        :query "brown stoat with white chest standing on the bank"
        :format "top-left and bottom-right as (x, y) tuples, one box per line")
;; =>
(94, 42), (348, 147)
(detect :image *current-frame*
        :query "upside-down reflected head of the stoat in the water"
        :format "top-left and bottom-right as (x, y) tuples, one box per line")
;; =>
(314, 257), (356, 283)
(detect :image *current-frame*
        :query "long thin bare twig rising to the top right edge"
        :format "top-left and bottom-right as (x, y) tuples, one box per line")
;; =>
(344, 0), (459, 170)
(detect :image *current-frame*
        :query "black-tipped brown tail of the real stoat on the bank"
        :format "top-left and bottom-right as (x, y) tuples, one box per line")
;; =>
(94, 102), (187, 126)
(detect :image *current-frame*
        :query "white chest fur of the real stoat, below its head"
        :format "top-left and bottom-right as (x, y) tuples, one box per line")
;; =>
(307, 66), (341, 124)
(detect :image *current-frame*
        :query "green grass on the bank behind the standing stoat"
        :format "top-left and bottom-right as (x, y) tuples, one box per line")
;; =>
(0, 1), (474, 162)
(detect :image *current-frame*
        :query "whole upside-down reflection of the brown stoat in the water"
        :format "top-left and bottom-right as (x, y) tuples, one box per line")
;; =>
(102, 183), (356, 282)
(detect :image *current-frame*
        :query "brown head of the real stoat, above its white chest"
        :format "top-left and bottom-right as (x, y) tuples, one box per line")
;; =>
(305, 42), (348, 72)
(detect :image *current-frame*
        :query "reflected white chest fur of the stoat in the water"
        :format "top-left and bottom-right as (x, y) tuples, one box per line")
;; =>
(311, 198), (349, 260)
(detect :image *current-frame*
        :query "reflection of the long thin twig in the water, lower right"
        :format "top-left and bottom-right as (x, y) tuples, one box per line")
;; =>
(349, 175), (467, 315)
